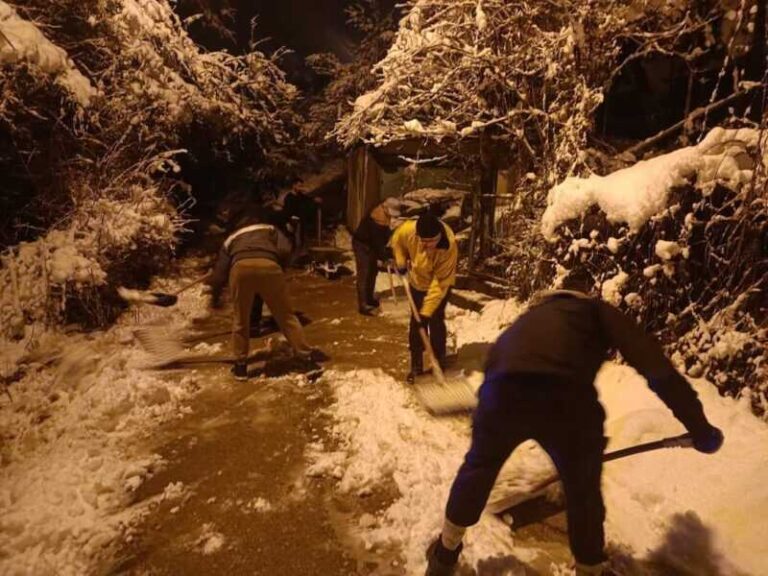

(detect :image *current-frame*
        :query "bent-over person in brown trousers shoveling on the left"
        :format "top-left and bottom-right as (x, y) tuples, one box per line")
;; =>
(208, 211), (327, 380)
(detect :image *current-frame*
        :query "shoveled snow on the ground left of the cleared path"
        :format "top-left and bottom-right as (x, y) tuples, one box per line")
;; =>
(0, 274), (213, 576)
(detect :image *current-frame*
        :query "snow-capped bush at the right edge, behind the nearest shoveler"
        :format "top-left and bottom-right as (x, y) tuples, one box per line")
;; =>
(542, 128), (768, 415)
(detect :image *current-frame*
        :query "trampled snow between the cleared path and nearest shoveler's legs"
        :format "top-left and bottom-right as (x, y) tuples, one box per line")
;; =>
(307, 370), (533, 574)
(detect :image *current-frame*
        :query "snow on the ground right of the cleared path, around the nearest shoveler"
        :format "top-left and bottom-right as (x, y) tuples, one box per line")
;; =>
(307, 301), (768, 576)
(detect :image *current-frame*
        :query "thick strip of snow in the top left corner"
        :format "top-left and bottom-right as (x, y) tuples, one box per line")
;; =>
(0, 0), (97, 107)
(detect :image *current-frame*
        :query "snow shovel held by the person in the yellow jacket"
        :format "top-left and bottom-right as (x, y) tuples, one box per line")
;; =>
(400, 276), (477, 416)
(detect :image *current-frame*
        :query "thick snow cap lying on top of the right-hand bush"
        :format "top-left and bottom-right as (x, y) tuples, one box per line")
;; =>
(541, 128), (768, 241)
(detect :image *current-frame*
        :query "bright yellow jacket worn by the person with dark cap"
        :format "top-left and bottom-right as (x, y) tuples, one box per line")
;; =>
(389, 220), (458, 316)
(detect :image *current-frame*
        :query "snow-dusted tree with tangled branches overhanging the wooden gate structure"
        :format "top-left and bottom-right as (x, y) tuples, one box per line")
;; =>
(335, 0), (755, 183)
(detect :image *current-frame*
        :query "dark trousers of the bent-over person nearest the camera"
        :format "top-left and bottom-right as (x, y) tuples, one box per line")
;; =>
(446, 375), (606, 565)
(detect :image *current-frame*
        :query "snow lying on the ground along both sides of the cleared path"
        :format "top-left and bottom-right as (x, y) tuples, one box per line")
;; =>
(0, 266), (768, 576)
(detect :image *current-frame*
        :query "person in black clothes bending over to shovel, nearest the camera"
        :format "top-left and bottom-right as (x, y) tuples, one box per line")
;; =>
(427, 274), (723, 576)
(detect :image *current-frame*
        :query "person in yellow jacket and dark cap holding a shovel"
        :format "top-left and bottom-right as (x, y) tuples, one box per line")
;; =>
(390, 213), (458, 384)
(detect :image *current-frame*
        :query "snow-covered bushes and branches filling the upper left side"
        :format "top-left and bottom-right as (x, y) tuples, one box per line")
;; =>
(0, 0), (295, 336)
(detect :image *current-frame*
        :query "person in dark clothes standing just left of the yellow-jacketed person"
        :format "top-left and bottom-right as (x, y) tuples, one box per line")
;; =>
(352, 203), (392, 316)
